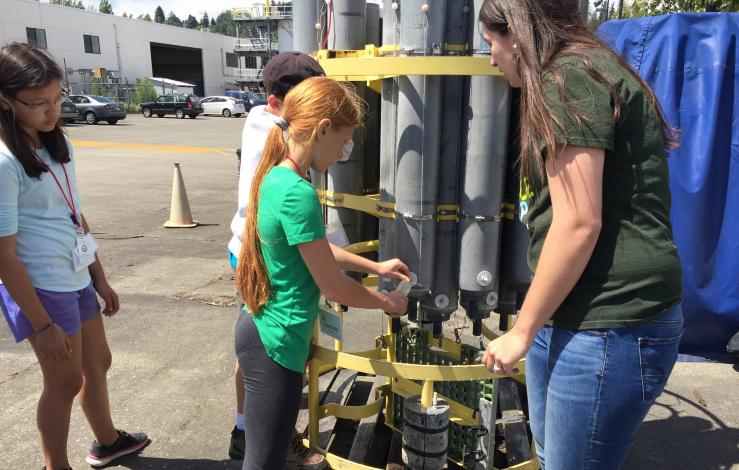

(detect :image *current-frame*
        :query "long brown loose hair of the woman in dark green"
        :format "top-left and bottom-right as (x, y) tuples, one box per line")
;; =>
(480, 0), (677, 182)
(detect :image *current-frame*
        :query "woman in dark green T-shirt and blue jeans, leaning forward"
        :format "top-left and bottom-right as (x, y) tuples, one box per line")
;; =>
(480, 0), (682, 470)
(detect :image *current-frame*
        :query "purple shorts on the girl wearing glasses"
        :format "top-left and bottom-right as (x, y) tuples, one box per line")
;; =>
(0, 283), (100, 343)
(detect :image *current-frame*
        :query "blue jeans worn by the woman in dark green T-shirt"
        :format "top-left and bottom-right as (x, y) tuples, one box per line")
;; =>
(526, 305), (683, 470)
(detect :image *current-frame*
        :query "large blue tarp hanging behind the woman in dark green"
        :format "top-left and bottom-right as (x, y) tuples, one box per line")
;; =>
(598, 13), (739, 355)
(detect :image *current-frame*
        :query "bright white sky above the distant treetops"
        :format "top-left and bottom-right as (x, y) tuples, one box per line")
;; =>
(47, 0), (379, 20)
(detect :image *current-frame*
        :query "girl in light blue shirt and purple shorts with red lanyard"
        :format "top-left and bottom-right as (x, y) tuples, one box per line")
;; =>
(0, 43), (149, 470)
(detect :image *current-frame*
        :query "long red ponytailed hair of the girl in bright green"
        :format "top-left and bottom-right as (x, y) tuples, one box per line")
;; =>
(236, 77), (363, 314)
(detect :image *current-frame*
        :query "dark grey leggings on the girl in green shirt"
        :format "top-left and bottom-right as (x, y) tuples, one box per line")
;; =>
(235, 312), (303, 470)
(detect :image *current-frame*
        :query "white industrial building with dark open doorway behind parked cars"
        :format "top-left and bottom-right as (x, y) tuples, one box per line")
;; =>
(0, 0), (239, 96)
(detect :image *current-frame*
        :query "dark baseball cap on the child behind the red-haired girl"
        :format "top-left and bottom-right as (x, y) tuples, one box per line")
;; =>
(262, 51), (326, 98)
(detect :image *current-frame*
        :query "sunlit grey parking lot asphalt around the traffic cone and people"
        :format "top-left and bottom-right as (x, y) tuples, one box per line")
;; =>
(0, 115), (739, 470)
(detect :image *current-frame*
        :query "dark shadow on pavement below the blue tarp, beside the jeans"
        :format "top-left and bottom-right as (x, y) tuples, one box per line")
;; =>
(623, 391), (739, 470)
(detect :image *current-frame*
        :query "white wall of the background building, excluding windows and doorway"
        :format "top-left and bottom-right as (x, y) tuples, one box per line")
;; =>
(0, 0), (234, 95)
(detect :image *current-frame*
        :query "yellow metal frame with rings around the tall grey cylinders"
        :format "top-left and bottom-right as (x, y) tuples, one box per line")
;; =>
(306, 44), (539, 470)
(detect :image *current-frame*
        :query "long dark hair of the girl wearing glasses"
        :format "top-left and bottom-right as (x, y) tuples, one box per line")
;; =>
(0, 42), (69, 178)
